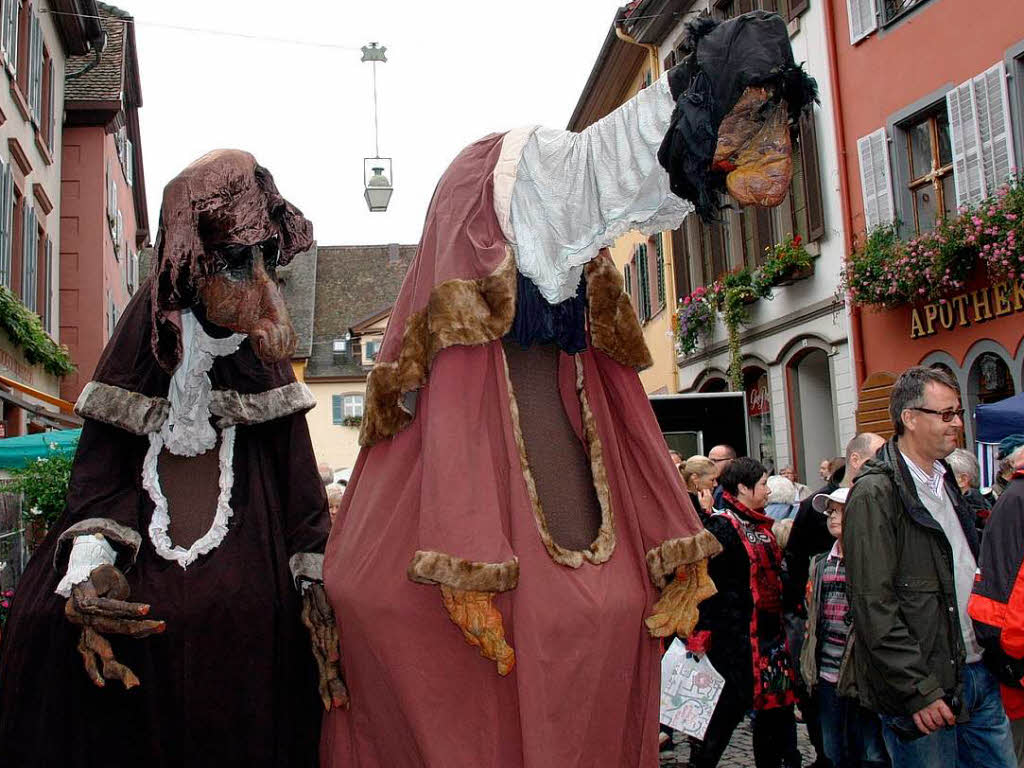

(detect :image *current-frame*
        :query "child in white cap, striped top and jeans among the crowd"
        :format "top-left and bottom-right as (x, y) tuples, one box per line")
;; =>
(800, 487), (890, 768)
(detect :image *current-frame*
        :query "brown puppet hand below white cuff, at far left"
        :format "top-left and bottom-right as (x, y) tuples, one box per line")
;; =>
(65, 565), (166, 688)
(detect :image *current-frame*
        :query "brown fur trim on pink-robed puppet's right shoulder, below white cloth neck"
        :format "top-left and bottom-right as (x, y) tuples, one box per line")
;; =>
(585, 250), (653, 371)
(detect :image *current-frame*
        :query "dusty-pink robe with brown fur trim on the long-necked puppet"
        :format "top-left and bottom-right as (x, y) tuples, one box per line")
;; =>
(322, 135), (719, 768)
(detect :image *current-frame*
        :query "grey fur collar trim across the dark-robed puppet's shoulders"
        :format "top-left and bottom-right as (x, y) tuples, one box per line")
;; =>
(75, 381), (316, 435)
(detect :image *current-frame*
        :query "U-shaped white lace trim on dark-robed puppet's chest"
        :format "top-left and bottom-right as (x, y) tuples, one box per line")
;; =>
(142, 427), (234, 568)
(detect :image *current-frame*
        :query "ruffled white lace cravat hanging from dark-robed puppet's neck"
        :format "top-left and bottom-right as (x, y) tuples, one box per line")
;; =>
(160, 310), (246, 456)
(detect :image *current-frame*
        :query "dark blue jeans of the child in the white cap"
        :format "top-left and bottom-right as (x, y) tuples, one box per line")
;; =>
(814, 680), (889, 768)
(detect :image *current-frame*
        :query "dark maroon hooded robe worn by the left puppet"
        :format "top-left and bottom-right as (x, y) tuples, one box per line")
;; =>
(0, 152), (328, 768)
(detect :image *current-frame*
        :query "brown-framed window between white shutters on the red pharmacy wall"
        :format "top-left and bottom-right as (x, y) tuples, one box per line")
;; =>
(903, 110), (956, 234)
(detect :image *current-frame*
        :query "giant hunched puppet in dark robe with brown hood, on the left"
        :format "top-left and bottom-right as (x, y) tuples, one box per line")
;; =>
(0, 151), (345, 768)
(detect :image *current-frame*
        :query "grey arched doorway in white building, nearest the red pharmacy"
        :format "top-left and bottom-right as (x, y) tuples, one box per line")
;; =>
(786, 346), (840, 489)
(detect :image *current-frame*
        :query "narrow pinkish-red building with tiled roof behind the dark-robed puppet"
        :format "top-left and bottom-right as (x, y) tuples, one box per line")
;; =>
(60, 4), (150, 400)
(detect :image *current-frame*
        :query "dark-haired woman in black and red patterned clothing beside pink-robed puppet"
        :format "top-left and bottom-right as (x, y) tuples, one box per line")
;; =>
(688, 457), (795, 768)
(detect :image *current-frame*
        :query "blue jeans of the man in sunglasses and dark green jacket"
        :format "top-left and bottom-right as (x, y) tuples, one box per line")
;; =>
(882, 662), (1017, 768)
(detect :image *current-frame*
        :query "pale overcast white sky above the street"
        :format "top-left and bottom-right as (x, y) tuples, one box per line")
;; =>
(128, 0), (625, 246)
